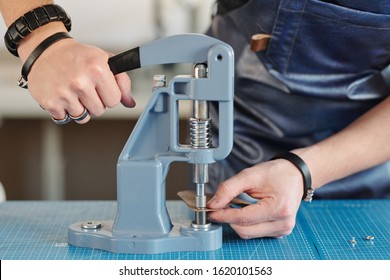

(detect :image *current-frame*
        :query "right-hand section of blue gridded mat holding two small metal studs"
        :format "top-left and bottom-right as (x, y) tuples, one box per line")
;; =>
(304, 201), (390, 260)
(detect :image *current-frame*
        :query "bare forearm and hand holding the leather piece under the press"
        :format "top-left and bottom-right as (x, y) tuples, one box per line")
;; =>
(208, 97), (390, 238)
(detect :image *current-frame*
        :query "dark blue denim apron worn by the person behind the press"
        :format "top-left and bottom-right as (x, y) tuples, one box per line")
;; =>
(208, 0), (390, 198)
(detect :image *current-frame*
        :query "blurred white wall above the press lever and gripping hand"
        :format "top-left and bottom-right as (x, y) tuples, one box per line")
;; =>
(0, 0), (215, 49)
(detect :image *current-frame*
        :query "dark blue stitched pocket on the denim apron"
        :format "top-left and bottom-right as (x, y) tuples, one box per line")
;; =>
(266, 0), (390, 75)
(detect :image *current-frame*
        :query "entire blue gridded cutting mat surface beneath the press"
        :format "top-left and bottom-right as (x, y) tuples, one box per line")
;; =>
(0, 200), (390, 260)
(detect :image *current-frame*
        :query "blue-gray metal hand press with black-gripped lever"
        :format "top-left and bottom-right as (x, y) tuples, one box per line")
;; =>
(68, 34), (234, 254)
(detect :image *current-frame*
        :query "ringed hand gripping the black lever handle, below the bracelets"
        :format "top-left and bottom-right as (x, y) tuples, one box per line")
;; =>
(28, 39), (135, 123)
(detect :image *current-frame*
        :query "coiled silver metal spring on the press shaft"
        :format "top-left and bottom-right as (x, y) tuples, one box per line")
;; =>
(190, 118), (212, 149)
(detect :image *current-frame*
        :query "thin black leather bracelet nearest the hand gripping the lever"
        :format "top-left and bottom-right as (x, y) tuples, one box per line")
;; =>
(18, 32), (72, 88)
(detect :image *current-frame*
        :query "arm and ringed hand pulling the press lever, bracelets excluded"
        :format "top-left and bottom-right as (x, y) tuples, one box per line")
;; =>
(0, 0), (135, 123)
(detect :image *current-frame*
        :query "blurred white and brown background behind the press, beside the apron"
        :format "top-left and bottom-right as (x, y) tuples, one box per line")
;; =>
(0, 0), (215, 200)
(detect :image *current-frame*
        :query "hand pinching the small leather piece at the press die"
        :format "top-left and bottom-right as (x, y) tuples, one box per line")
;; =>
(207, 159), (303, 239)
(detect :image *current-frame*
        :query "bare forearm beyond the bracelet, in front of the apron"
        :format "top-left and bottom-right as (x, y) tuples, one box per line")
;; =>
(294, 98), (390, 188)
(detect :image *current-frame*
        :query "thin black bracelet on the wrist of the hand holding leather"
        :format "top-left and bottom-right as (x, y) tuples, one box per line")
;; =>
(272, 152), (314, 202)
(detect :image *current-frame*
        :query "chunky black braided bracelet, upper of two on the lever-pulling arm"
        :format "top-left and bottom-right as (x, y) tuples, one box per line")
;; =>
(4, 4), (72, 56)
